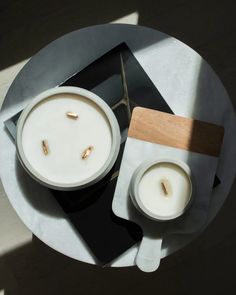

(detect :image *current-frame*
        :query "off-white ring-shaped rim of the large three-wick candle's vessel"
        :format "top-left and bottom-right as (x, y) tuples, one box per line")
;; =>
(16, 86), (121, 190)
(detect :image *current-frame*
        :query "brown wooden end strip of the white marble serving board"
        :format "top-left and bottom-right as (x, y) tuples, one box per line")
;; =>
(128, 107), (224, 157)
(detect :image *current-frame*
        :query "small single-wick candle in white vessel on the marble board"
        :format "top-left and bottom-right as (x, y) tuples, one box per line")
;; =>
(130, 159), (192, 221)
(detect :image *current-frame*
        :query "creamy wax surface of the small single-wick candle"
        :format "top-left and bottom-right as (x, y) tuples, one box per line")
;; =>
(138, 163), (191, 217)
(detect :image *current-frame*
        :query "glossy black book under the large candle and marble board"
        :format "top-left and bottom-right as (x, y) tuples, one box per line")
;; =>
(52, 43), (171, 264)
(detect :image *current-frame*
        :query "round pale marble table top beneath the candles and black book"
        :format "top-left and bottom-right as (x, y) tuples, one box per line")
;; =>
(0, 24), (236, 266)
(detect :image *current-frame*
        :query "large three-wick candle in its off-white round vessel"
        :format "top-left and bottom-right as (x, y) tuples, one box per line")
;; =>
(16, 87), (120, 190)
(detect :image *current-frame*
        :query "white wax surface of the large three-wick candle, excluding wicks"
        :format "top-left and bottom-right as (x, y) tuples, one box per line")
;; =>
(22, 93), (112, 184)
